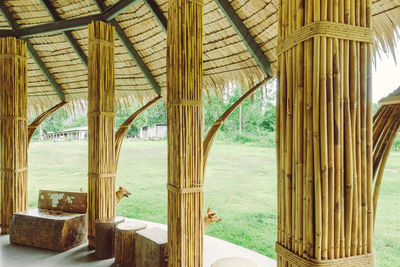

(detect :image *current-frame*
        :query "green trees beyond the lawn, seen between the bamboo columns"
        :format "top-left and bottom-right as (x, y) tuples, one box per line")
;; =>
(32, 81), (276, 143)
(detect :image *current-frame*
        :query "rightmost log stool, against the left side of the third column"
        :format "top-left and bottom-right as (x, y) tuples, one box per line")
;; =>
(135, 227), (168, 267)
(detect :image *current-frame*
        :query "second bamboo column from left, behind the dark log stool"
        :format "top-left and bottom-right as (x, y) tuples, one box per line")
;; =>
(88, 21), (115, 248)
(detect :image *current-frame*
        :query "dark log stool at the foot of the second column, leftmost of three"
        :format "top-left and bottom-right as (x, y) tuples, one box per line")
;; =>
(95, 216), (125, 259)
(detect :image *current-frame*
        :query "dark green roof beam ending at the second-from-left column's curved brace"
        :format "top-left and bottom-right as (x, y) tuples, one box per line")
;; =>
(95, 0), (161, 96)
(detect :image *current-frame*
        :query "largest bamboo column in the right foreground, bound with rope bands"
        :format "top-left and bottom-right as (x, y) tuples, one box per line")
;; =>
(276, 0), (374, 266)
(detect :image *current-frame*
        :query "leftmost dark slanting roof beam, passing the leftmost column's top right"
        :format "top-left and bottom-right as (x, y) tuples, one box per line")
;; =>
(0, 2), (65, 101)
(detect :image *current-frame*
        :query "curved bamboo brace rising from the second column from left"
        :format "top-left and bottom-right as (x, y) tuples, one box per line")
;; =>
(115, 96), (162, 172)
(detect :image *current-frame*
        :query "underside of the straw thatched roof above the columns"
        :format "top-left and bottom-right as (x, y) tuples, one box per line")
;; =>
(0, 0), (400, 111)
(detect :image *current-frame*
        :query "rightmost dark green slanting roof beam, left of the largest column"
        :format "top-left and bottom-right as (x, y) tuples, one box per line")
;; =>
(215, 0), (271, 75)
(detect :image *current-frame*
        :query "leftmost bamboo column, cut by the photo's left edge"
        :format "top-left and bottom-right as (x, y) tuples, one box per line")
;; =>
(0, 37), (28, 234)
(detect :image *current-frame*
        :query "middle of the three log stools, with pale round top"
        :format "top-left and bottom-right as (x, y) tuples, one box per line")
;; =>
(115, 221), (147, 267)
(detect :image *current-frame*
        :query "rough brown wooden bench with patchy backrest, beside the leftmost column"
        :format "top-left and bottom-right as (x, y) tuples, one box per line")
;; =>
(10, 190), (87, 251)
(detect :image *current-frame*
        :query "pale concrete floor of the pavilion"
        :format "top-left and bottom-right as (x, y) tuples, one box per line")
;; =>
(0, 222), (276, 267)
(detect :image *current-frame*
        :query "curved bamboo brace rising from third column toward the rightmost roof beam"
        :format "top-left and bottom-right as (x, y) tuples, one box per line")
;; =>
(203, 76), (272, 173)
